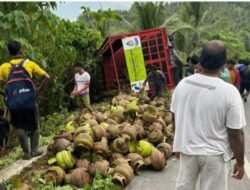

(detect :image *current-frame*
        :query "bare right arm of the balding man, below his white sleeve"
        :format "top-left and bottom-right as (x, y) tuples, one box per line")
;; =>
(228, 128), (245, 179)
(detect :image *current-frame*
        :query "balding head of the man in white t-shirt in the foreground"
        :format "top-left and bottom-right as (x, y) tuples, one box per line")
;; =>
(199, 40), (227, 73)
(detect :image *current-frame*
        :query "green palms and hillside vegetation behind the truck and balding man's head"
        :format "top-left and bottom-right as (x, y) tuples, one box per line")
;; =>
(78, 2), (250, 60)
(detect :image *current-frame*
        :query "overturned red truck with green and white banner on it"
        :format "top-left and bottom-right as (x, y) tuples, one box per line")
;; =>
(98, 28), (175, 91)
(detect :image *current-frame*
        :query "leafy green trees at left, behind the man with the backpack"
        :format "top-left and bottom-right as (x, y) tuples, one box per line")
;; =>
(0, 3), (102, 114)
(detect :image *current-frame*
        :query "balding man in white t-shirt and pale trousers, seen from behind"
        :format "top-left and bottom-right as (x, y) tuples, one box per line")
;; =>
(171, 40), (246, 190)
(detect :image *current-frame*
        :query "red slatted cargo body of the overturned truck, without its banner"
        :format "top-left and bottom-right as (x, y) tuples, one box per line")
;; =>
(98, 28), (174, 91)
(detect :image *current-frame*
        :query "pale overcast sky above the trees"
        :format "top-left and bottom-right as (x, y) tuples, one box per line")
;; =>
(55, 1), (132, 21)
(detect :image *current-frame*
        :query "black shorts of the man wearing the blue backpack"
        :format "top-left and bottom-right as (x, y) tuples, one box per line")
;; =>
(10, 108), (39, 131)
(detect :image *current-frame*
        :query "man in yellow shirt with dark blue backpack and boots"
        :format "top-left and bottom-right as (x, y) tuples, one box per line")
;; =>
(0, 41), (50, 160)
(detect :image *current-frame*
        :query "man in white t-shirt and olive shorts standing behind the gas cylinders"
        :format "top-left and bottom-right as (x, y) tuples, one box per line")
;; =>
(71, 63), (93, 113)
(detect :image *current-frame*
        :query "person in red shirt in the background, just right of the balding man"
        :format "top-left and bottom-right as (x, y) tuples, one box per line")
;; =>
(227, 59), (240, 89)
